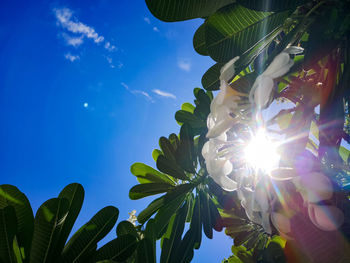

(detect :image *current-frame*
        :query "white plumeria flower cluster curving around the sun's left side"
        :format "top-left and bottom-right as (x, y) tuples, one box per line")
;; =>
(202, 47), (344, 238)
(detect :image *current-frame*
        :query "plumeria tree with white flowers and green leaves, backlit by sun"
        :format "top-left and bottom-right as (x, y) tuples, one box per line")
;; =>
(130, 0), (350, 262)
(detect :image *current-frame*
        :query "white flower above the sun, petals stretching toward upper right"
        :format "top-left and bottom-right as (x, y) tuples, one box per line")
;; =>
(249, 46), (303, 109)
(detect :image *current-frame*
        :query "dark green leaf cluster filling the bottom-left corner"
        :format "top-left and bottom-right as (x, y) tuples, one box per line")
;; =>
(0, 183), (139, 263)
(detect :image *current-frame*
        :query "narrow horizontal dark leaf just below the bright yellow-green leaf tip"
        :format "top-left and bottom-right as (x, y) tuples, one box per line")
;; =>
(129, 183), (174, 200)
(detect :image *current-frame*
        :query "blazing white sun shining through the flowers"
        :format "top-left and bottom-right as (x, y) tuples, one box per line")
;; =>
(244, 129), (280, 173)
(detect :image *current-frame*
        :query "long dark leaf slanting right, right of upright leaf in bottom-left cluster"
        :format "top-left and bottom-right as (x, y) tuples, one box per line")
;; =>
(62, 206), (119, 262)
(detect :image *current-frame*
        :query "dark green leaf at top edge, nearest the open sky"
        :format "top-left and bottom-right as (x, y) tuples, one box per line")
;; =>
(146, 0), (234, 22)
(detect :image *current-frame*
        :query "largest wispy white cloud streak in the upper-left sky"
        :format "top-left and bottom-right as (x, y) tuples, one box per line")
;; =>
(54, 8), (104, 43)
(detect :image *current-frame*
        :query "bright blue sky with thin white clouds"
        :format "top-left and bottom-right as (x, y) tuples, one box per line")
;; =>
(0, 0), (232, 262)
